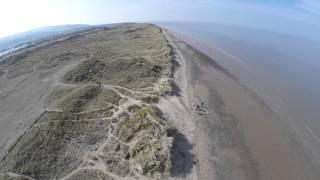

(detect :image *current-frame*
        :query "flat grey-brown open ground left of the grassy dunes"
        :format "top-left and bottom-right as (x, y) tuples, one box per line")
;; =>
(0, 57), (81, 159)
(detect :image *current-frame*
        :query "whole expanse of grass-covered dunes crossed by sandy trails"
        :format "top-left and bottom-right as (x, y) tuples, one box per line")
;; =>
(0, 24), (173, 180)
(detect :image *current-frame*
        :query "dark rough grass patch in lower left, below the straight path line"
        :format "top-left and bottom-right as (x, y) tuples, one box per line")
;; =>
(0, 113), (109, 179)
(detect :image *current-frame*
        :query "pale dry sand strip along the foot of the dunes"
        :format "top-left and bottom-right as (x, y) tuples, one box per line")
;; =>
(158, 31), (198, 180)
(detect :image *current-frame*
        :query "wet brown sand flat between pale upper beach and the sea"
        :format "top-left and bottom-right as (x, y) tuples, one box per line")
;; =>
(166, 32), (320, 180)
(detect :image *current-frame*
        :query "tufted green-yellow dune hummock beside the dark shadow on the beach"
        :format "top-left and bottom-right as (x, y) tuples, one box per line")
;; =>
(115, 104), (172, 176)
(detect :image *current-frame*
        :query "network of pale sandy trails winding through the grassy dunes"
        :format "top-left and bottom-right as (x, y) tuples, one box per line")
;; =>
(0, 59), (168, 180)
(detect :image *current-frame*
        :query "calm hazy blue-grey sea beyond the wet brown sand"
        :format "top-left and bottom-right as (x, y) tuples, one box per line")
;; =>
(158, 23), (320, 162)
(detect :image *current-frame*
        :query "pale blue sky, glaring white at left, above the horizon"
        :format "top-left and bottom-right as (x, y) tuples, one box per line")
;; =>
(0, 0), (320, 37)
